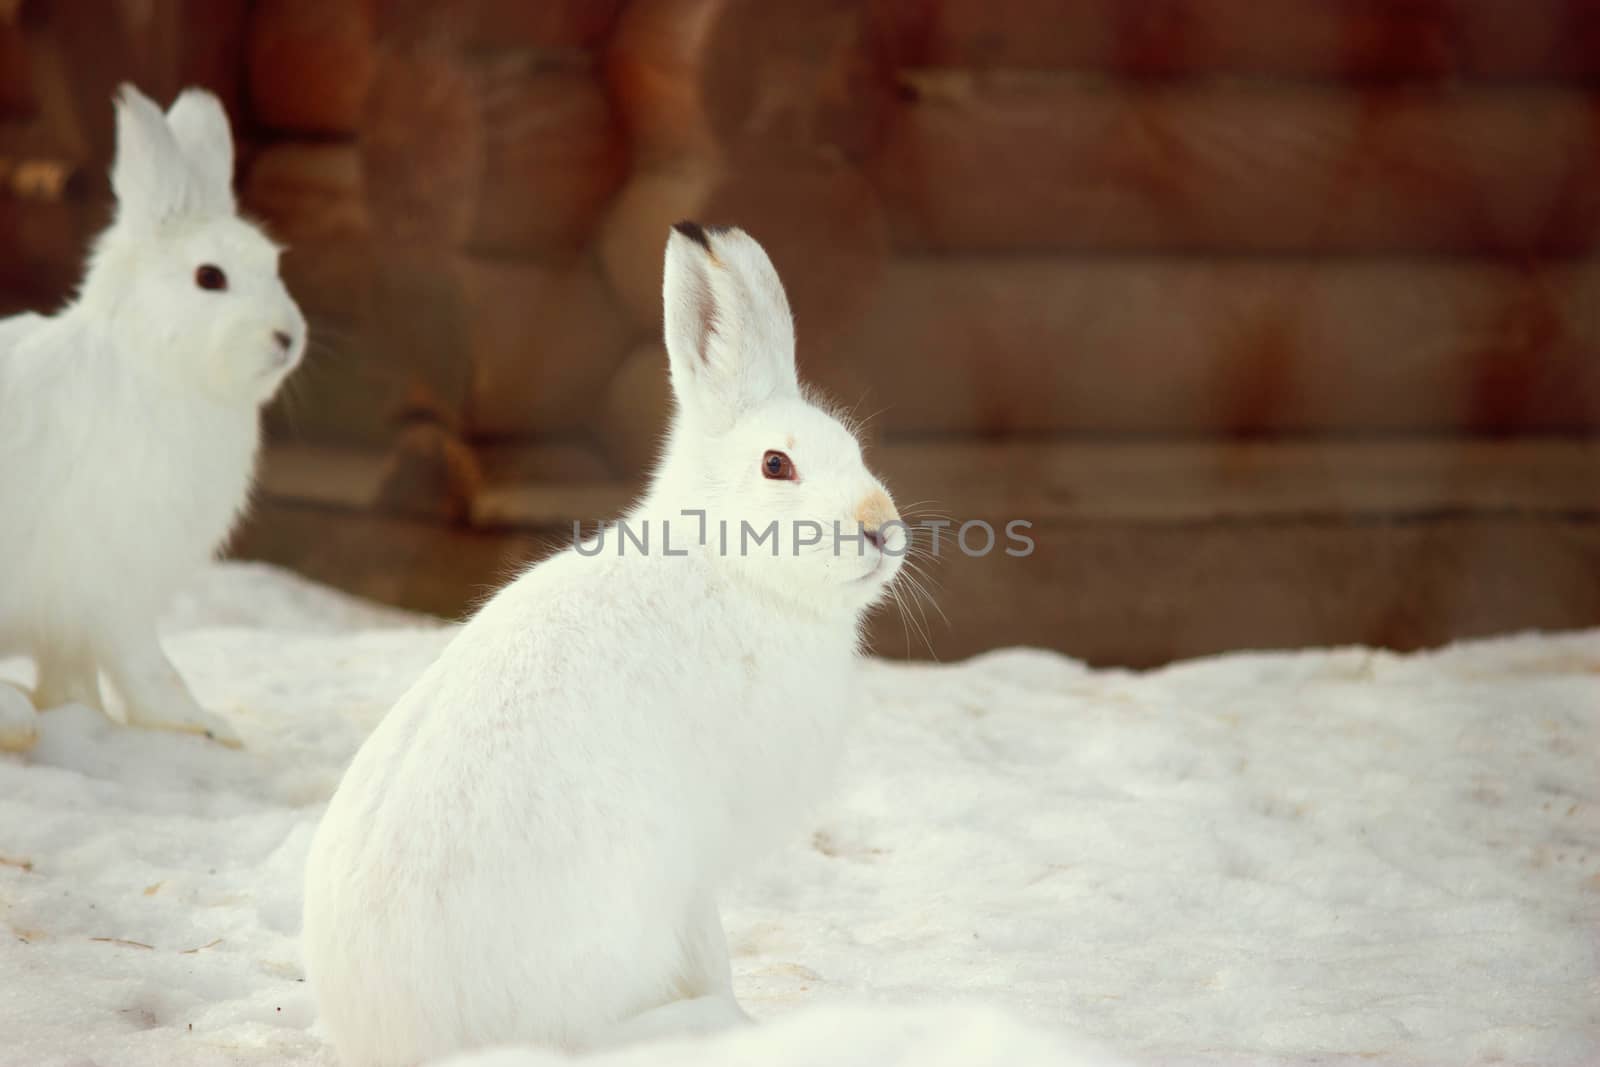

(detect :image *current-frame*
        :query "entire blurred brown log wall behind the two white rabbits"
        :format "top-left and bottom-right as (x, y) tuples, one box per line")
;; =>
(0, 0), (1600, 665)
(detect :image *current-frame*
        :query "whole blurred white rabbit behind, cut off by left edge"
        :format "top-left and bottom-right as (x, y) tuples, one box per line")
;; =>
(0, 86), (306, 749)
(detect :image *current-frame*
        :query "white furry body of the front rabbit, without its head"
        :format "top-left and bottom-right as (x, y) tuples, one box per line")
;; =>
(296, 534), (854, 1064)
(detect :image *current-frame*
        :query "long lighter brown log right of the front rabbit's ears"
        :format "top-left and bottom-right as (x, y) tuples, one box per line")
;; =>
(843, 259), (1600, 434)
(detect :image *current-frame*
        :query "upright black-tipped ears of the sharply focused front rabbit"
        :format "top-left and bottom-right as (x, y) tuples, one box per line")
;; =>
(662, 222), (800, 430)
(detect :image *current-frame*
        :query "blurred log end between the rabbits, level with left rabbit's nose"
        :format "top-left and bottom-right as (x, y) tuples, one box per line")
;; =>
(456, 259), (627, 438)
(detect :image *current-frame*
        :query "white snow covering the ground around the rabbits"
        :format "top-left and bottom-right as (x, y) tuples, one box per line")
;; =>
(0, 565), (1600, 1067)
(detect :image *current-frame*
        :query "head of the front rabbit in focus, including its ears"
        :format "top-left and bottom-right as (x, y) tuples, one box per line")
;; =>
(654, 222), (909, 613)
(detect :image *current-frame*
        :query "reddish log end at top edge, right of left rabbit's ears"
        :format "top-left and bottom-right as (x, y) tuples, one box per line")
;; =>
(248, 0), (378, 134)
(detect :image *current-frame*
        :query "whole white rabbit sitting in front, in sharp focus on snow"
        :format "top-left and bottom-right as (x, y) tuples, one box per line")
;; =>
(304, 222), (907, 1067)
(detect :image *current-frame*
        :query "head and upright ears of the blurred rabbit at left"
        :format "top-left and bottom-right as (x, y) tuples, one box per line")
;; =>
(78, 85), (306, 405)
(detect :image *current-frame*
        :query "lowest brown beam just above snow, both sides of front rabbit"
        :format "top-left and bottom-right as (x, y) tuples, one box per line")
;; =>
(222, 499), (1600, 667)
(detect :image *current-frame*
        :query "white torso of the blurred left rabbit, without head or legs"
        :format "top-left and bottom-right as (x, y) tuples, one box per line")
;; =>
(0, 312), (258, 648)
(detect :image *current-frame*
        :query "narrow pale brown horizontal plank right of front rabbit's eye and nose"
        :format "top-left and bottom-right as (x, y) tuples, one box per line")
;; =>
(872, 438), (1600, 528)
